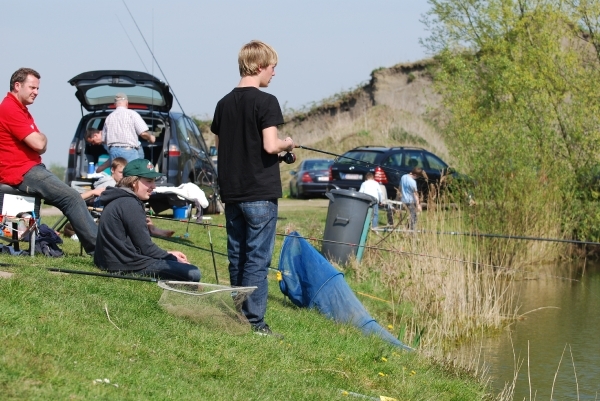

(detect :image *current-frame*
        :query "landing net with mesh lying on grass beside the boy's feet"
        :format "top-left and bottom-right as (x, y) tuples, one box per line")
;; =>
(158, 281), (256, 334)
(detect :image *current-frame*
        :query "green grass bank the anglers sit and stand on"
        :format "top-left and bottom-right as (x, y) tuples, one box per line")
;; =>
(0, 202), (486, 400)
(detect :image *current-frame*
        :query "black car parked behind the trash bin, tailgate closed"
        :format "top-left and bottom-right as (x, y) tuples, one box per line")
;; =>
(329, 146), (450, 199)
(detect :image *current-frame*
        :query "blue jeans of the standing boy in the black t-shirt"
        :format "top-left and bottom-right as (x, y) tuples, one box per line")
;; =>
(225, 199), (277, 328)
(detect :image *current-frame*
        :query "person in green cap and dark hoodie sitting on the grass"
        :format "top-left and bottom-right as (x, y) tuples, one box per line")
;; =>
(94, 159), (200, 281)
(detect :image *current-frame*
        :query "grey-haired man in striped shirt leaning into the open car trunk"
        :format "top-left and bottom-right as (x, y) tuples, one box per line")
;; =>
(102, 93), (156, 162)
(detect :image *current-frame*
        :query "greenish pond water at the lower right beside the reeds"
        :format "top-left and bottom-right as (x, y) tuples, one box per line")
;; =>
(482, 262), (600, 400)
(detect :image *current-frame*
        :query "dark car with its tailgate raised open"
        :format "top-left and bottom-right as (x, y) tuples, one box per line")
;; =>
(66, 70), (219, 213)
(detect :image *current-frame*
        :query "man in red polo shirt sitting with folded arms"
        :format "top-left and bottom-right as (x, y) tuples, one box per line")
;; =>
(0, 68), (98, 254)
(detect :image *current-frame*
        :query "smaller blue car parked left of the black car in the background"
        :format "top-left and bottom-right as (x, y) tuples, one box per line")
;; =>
(290, 159), (333, 198)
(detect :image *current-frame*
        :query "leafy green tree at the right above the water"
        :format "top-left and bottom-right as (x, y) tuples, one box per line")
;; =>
(423, 0), (600, 251)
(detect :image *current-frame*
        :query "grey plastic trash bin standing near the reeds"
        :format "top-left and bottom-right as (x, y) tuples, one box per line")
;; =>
(321, 189), (376, 264)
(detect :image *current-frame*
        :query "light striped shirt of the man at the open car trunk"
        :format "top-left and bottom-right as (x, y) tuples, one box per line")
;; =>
(102, 107), (148, 149)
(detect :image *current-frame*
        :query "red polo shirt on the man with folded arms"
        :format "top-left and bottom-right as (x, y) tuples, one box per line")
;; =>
(0, 92), (42, 185)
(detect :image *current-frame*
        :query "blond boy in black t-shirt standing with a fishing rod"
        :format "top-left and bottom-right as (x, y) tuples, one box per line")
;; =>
(211, 40), (294, 337)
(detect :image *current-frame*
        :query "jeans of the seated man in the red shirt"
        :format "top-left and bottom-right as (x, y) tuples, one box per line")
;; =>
(17, 164), (98, 253)
